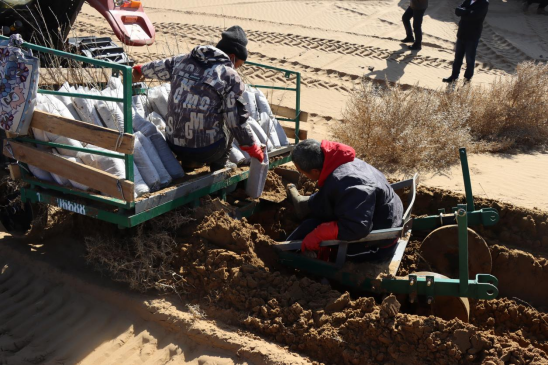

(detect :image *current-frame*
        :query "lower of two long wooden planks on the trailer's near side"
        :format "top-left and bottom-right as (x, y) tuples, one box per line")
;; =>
(3, 140), (134, 201)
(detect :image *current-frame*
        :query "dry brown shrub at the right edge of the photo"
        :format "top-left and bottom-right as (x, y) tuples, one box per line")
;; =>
(462, 61), (548, 151)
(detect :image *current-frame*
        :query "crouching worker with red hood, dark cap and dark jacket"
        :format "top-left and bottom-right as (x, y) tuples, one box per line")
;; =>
(287, 139), (403, 261)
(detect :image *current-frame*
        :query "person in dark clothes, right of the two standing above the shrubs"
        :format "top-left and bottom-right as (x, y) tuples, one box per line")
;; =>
(442, 0), (489, 83)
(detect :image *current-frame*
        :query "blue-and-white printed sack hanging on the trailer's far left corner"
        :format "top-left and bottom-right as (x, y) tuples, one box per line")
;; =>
(0, 34), (40, 135)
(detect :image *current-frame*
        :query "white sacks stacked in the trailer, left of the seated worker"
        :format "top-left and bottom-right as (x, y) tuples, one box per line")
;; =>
(29, 78), (184, 197)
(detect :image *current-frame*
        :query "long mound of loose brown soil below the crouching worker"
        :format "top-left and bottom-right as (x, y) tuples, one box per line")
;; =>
(177, 209), (548, 364)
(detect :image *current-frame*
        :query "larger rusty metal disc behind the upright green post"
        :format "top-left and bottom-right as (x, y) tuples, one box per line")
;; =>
(419, 225), (492, 279)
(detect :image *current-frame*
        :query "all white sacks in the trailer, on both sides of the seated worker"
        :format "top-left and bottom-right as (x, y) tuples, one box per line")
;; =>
(29, 77), (289, 197)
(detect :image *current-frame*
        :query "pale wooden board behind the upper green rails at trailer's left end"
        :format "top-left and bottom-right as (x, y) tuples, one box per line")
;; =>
(40, 67), (112, 87)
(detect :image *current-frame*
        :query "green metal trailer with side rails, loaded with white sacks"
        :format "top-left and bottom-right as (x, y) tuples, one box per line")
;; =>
(2, 37), (301, 228)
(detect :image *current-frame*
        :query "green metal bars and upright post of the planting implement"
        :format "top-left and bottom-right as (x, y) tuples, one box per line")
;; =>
(278, 148), (499, 300)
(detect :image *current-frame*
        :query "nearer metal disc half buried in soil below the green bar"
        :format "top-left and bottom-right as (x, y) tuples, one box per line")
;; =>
(396, 271), (470, 322)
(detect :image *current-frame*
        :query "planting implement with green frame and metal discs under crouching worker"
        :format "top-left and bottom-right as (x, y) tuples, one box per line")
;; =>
(276, 148), (499, 321)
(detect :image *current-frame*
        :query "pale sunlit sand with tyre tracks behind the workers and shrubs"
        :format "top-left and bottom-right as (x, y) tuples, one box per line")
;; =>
(76, 0), (548, 209)
